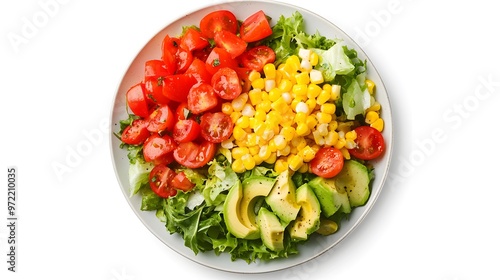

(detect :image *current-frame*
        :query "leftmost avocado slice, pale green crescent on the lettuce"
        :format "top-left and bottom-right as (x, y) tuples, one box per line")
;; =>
(222, 183), (255, 238)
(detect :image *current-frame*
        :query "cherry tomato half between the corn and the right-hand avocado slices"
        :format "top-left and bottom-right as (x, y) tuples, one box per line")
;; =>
(310, 147), (344, 178)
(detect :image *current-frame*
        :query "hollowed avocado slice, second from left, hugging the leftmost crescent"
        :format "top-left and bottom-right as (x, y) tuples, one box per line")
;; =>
(240, 176), (276, 239)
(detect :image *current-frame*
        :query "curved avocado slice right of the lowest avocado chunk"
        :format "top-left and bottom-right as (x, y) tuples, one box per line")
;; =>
(289, 183), (321, 241)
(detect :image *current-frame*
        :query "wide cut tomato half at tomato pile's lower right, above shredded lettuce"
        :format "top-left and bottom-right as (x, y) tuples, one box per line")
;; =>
(174, 141), (217, 168)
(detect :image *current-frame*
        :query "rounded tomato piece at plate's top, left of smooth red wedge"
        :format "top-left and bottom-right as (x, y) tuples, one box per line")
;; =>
(200, 10), (238, 39)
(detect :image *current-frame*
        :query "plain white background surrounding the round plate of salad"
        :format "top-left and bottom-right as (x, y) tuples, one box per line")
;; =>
(0, 0), (500, 280)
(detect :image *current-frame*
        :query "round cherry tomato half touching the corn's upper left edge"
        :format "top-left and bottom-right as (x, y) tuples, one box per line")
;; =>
(212, 67), (242, 100)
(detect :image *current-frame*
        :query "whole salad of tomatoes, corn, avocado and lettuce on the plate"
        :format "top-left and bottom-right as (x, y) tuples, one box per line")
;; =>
(115, 10), (385, 263)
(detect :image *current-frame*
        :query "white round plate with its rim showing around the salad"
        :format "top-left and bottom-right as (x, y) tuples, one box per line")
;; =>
(110, 1), (393, 273)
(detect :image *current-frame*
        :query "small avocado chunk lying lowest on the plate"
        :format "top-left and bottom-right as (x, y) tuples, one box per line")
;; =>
(257, 207), (285, 252)
